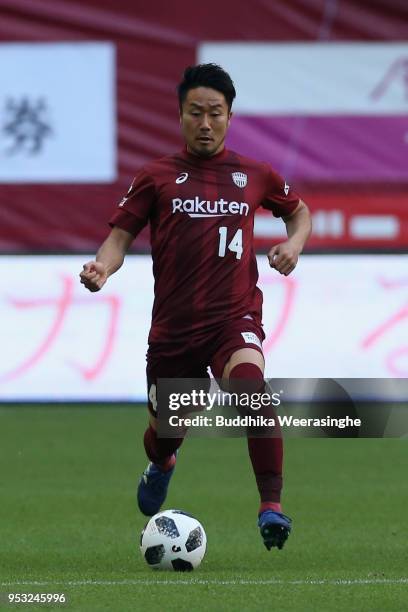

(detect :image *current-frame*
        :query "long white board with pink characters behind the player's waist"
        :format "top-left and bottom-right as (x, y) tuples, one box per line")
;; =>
(0, 255), (408, 401)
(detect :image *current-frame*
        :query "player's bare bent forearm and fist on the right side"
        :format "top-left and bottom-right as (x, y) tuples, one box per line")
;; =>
(268, 200), (312, 276)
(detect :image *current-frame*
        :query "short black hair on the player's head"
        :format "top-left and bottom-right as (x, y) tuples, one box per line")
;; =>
(177, 64), (236, 110)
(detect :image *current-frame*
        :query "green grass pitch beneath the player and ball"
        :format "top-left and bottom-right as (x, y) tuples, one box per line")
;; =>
(0, 405), (408, 612)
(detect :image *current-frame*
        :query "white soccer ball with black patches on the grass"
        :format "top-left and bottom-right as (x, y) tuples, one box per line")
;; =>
(140, 510), (207, 572)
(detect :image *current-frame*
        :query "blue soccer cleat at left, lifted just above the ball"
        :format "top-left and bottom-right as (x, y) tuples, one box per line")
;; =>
(137, 454), (176, 516)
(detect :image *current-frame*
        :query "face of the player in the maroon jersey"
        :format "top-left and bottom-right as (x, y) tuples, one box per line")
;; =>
(180, 87), (232, 157)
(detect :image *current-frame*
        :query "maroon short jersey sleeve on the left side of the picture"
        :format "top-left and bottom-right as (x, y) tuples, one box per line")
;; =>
(109, 169), (156, 236)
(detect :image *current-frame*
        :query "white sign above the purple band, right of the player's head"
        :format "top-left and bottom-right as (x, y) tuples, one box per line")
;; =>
(198, 42), (408, 115)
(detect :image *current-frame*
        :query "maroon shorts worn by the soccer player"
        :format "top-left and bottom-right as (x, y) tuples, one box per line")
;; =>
(146, 317), (265, 416)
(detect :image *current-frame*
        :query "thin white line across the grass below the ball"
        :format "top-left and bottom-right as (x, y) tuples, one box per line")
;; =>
(0, 578), (408, 587)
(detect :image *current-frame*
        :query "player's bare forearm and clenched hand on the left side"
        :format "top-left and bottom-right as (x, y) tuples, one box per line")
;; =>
(79, 227), (134, 291)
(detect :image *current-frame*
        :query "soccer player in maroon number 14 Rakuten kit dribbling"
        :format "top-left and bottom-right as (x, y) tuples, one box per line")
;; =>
(80, 64), (311, 550)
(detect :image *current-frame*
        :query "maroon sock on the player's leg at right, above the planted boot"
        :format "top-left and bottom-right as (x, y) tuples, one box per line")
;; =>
(230, 363), (283, 508)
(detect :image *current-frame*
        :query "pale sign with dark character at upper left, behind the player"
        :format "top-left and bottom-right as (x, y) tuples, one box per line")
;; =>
(0, 42), (117, 183)
